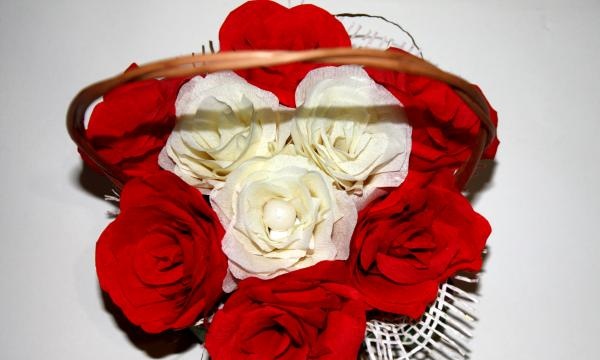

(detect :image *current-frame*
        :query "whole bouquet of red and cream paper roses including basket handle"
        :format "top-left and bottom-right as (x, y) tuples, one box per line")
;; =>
(68, 1), (498, 360)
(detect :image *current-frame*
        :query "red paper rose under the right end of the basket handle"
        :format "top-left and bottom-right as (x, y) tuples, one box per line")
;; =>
(367, 49), (499, 171)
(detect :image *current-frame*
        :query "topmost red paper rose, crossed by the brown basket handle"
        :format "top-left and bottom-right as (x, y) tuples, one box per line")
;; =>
(219, 0), (351, 107)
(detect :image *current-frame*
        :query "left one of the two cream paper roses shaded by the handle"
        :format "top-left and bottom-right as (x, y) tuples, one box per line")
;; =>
(159, 72), (290, 194)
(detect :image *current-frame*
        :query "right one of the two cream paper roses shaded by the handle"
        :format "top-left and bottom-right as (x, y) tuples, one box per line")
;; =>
(291, 66), (412, 209)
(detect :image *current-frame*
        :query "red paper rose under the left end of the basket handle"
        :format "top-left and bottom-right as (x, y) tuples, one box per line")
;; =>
(84, 66), (185, 177)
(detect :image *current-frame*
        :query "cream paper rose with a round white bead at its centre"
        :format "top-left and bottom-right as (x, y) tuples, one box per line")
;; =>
(211, 154), (357, 291)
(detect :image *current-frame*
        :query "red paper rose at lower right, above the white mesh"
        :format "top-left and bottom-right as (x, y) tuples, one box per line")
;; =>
(349, 172), (490, 318)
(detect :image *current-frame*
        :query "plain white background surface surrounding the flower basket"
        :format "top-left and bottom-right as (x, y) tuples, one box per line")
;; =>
(0, 0), (600, 360)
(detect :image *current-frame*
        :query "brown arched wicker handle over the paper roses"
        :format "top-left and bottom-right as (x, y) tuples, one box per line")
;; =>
(67, 48), (496, 189)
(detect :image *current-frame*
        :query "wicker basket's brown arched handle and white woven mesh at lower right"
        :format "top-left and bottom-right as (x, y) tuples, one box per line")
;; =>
(67, 48), (496, 360)
